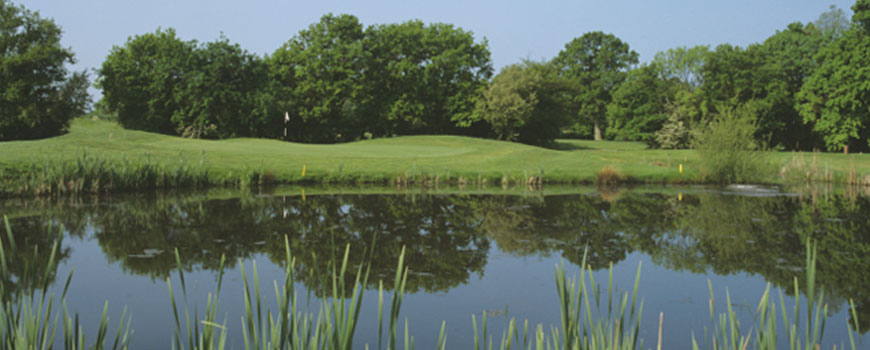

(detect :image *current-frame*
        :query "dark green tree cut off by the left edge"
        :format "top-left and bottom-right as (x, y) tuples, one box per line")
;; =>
(0, 0), (90, 141)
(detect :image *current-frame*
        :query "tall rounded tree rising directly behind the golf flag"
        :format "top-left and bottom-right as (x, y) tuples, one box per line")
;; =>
(267, 14), (365, 142)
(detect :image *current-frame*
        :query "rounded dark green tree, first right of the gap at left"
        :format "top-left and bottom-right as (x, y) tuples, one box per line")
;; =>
(97, 28), (196, 134)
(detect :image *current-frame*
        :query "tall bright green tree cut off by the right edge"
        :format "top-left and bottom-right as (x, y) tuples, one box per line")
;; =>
(797, 0), (870, 150)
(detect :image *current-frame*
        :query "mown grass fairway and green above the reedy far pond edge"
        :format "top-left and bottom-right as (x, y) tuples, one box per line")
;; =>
(0, 119), (870, 191)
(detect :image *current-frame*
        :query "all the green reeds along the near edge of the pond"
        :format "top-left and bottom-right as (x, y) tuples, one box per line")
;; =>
(0, 213), (860, 350)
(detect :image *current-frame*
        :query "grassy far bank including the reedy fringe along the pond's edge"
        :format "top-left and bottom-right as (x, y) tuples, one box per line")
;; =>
(0, 119), (870, 194)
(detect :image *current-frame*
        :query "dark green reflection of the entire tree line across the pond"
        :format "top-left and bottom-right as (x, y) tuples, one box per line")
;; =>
(0, 191), (870, 331)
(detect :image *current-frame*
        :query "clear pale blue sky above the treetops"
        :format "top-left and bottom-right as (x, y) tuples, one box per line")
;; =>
(18, 0), (854, 85)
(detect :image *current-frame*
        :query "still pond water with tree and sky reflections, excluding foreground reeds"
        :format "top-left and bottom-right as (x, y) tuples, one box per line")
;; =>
(0, 188), (870, 349)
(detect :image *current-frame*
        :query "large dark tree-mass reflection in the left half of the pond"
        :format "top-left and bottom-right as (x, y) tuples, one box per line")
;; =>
(1, 196), (489, 294)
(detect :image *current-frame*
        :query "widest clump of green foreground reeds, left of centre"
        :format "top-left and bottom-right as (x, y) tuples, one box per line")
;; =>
(170, 237), (422, 350)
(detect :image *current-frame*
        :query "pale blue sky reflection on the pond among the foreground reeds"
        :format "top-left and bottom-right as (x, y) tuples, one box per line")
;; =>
(56, 228), (870, 349)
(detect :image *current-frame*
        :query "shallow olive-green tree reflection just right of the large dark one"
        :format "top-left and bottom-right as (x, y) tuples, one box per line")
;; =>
(477, 193), (673, 269)
